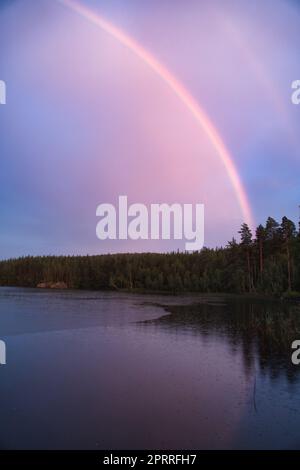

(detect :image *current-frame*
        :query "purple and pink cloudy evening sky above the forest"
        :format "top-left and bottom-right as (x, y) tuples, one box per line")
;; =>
(0, 0), (300, 259)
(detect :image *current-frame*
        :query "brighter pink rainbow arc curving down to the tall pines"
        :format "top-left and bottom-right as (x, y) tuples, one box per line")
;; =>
(57, 0), (254, 227)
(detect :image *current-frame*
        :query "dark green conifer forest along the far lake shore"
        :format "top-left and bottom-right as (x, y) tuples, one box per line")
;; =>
(0, 217), (300, 295)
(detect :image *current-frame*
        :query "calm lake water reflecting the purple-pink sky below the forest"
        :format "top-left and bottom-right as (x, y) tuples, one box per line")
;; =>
(0, 288), (300, 449)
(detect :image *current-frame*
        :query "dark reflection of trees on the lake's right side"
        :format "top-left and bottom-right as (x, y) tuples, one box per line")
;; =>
(142, 298), (300, 382)
